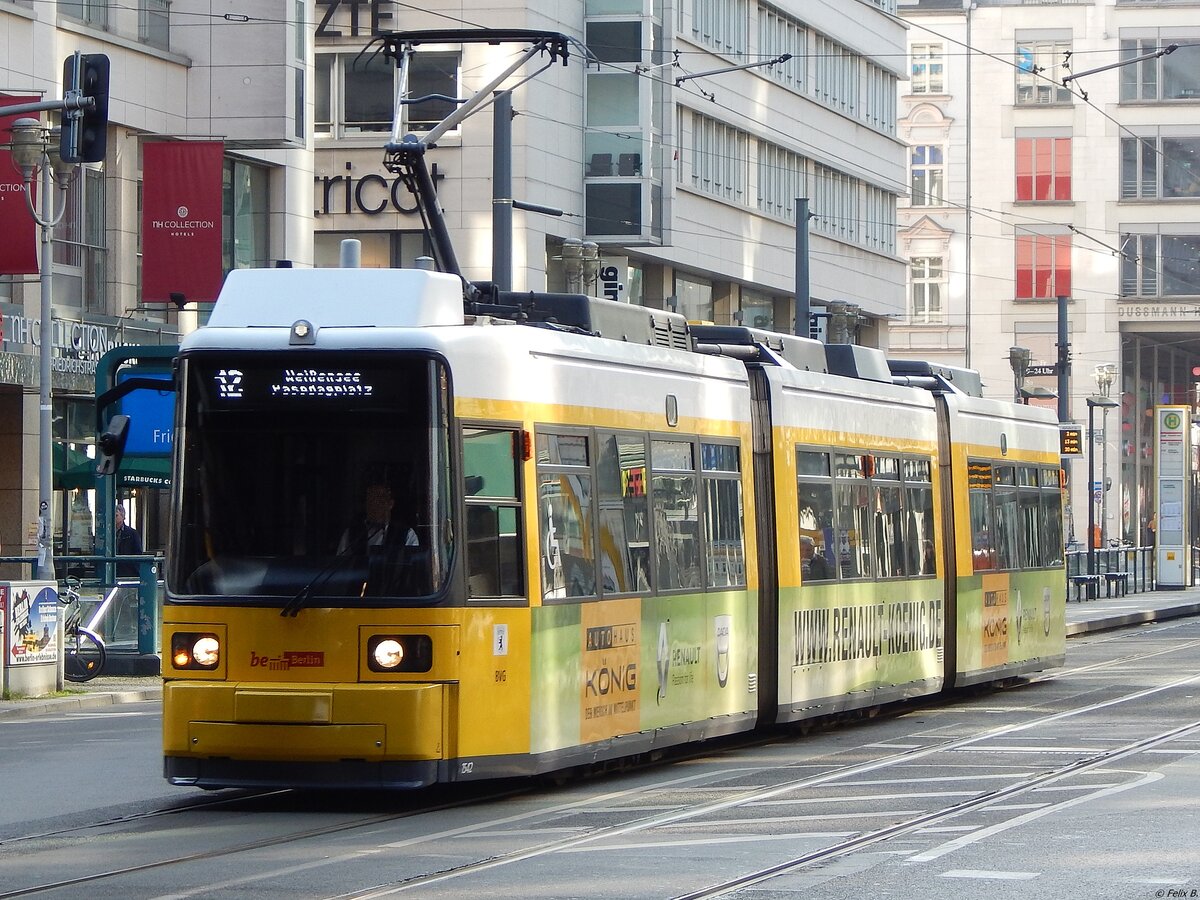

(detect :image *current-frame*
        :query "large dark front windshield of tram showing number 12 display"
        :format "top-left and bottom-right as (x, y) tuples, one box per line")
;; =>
(167, 352), (452, 607)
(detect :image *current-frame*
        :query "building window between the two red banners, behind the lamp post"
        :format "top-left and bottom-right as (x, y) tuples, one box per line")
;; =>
(53, 166), (108, 313)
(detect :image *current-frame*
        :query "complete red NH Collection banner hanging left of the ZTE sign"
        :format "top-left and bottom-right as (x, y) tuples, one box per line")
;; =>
(142, 140), (224, 304)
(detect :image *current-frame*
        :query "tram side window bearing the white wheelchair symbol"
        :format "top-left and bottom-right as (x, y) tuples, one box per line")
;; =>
(536, 433), (596, 600)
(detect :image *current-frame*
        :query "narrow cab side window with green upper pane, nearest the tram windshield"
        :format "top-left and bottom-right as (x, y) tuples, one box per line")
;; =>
(462, 428), (524, 598)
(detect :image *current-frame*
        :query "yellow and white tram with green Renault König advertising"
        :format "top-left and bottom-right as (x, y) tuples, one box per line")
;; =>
(163, 269), (1064, 787)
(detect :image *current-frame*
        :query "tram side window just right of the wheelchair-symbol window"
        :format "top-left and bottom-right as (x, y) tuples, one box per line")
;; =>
(596, 431), (652, 594)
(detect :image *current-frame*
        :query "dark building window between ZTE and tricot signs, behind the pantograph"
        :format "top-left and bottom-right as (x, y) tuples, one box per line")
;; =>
(313, 50), (458, 138)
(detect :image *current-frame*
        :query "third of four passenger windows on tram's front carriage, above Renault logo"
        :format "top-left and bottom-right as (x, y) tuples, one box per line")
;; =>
(650, 440), (702, 592)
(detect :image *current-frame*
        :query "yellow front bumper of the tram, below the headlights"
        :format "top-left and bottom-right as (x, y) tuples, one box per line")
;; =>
(163, 682), (450, 762)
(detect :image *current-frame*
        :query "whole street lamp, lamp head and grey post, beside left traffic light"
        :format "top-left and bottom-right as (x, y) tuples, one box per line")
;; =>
(11, 119), (76, 581)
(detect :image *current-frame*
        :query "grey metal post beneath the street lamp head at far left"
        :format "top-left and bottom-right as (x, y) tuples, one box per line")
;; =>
(34, 154), (56, 581)
